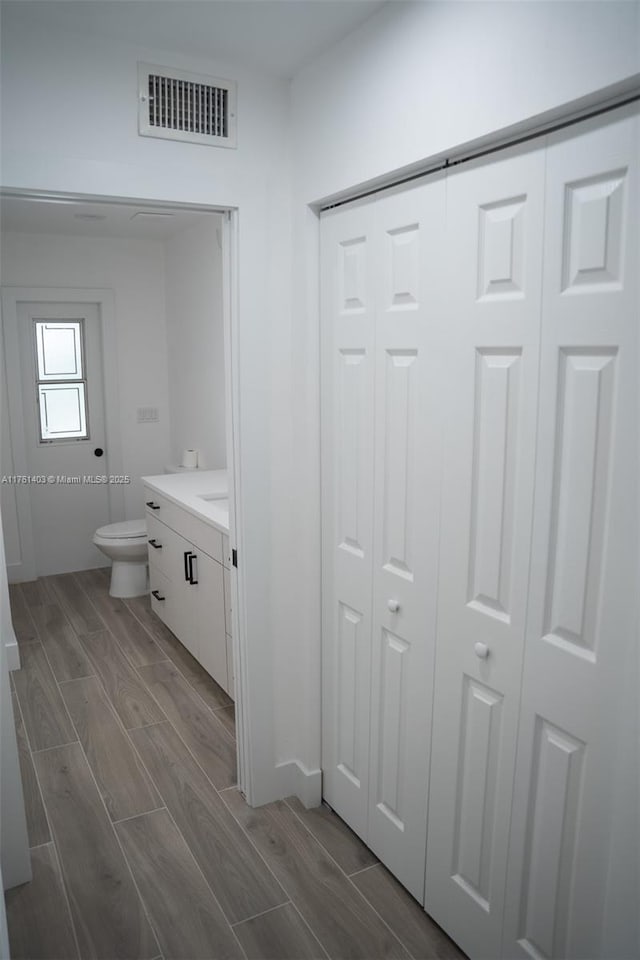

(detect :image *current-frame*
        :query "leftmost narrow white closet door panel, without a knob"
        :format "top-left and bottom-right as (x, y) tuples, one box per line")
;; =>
(321, 204), (375, 838)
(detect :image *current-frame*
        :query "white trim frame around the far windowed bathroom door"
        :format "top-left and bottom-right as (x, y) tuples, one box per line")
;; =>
(1, 286), (124, 580)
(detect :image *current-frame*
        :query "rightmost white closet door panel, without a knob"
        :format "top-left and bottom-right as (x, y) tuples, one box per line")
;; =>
(504, 110), (639, 960)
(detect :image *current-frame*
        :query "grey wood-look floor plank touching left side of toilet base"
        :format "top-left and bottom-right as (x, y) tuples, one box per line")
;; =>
(74, 570), (167, 667)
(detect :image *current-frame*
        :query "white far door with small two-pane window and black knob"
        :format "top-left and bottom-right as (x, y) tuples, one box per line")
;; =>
(18, 302), (110, 576)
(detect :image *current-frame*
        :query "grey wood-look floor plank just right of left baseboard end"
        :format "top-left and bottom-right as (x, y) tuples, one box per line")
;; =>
(13, 643), (78, 750)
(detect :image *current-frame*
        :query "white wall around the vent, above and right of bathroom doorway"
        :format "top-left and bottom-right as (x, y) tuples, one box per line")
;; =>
(1, 3), (292, 803)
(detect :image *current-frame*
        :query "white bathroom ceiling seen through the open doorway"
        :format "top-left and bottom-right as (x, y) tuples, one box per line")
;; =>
(0, 197), (220, 240)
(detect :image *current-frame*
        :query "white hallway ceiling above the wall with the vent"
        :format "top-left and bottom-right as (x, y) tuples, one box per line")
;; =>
(2, 0), (384, 78)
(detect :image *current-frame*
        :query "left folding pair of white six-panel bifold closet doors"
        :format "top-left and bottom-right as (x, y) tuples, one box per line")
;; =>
(322, 177), (444, 900)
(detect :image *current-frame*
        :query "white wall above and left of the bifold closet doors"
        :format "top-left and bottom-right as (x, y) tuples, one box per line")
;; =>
(280, 0), (640, 788)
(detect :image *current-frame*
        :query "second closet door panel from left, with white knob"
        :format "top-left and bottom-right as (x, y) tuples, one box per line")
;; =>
(368, 177), (445, 901)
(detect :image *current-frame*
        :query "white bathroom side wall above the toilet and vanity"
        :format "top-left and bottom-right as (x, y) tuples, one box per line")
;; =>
(165, 214), (227, 470)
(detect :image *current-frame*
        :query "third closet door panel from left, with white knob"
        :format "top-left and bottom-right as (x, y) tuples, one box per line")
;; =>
(425, 144), (544, 958)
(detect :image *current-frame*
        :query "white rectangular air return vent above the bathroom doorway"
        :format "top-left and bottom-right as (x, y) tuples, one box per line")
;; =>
(138, 63), (236, 147)
